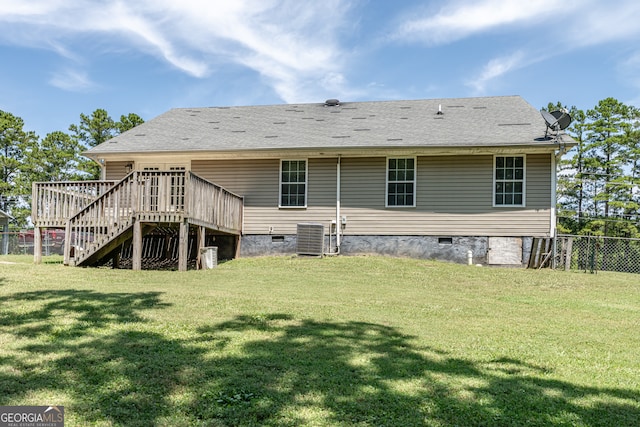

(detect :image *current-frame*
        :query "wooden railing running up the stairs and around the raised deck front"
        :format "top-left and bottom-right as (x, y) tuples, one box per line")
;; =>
(56, 171), (243, 263)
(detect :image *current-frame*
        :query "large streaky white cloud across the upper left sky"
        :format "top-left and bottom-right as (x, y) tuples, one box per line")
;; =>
(0, 0), (356, 102)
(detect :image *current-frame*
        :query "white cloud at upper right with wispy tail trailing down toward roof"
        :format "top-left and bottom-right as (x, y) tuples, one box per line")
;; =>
(394, 0), (640, 94)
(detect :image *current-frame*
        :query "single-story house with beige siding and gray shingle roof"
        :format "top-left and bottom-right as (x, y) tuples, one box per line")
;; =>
(34, 96), (575, 269)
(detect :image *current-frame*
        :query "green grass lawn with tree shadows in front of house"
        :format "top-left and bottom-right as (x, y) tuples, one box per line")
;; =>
(0, 257), (640, 426)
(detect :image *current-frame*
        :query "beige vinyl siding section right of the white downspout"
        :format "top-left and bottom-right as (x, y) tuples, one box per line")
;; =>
(341, 154), (551, 236)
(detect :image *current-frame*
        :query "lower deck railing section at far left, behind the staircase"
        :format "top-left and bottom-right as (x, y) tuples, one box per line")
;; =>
(31, 181), (117, 227)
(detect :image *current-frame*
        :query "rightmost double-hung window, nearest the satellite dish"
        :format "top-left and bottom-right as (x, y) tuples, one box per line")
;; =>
(493, 156), (525, 206)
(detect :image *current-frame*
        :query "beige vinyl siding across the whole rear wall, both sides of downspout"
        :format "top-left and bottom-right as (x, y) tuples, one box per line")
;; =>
(192, 154), (551, 236)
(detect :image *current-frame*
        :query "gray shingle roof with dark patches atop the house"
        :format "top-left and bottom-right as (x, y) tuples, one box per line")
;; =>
(86, 96), (568, 157)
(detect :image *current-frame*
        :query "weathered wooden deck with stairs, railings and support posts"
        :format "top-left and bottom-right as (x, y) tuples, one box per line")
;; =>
(32, 171), (244, 270)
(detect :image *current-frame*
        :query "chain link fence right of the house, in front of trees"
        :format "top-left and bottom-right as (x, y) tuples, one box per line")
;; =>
(554, 235), (640, 274)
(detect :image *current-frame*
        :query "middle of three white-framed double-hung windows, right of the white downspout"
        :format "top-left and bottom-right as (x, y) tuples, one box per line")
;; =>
(387, 157), (416, 207)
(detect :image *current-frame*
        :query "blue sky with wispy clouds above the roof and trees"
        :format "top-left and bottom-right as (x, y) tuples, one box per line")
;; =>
(0, 0), (640, 137)
